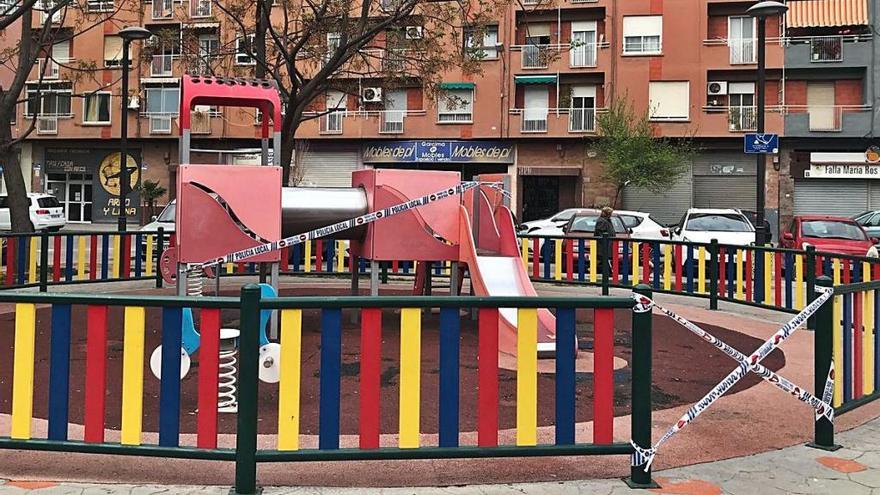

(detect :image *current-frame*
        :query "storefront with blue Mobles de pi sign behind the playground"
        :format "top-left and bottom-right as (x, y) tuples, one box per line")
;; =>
(362, 141), (515, 180)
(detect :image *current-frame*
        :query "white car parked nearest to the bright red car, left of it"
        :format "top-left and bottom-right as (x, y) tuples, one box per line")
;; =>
(672, 208), (755, 246)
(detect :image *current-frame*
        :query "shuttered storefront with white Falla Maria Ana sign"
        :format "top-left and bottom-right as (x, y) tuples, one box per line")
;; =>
(792, 152), (880, 217)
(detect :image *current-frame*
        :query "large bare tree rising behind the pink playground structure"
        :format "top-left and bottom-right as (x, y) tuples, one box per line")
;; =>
(198, 0), (506, 184)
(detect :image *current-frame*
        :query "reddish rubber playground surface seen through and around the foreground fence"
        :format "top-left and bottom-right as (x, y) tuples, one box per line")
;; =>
(0, 283), (880, 486)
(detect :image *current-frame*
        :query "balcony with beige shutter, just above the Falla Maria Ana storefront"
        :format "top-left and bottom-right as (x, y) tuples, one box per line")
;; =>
(785, 105), (872, 137)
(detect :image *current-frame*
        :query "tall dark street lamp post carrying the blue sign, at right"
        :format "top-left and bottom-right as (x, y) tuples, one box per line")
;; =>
(746, 0), (788, 246)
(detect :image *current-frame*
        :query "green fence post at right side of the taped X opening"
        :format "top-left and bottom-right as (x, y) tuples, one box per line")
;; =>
(807, 275), (843, 451)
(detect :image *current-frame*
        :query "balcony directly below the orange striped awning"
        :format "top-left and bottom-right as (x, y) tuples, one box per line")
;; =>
(785, 35), (871, 69)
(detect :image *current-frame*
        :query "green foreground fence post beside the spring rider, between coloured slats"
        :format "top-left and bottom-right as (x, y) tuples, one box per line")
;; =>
(234, 284), (261, 495)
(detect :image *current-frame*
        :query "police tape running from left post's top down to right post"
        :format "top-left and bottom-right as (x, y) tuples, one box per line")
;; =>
(633, 294), (834, 421)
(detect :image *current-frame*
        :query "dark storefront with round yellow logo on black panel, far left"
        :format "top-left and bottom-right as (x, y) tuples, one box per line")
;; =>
(42, 148), (141, 223)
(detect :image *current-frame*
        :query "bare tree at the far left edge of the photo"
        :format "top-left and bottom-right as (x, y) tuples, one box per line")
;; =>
(0, 0), (131, 232)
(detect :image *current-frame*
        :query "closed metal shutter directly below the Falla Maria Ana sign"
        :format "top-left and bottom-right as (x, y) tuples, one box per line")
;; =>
(794, 179), (868, 217)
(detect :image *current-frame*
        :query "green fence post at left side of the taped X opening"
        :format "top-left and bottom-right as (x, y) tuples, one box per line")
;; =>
(624, 284), (660, 488)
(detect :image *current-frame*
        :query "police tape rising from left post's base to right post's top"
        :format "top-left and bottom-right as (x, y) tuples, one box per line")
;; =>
(630, 287), (834, 472)
